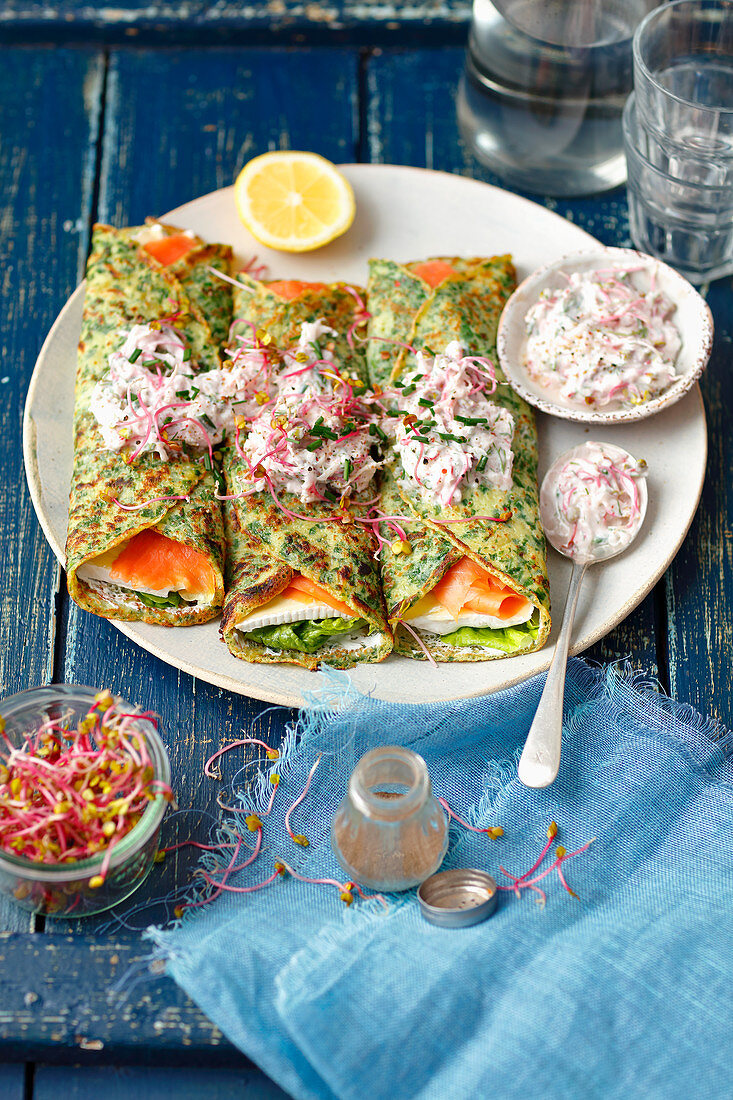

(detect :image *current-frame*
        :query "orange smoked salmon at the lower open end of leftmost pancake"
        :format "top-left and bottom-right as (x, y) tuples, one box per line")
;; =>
(109, 529), (216, 598)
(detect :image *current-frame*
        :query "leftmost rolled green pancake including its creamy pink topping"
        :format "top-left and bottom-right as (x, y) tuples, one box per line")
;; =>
(66, 222), (232, 626)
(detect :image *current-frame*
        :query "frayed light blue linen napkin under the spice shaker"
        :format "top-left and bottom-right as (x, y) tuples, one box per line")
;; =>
(150, 659), (733, 1100)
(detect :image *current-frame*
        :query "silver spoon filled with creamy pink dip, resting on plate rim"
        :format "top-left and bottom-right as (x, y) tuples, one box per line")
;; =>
(518, 440), (647, 788)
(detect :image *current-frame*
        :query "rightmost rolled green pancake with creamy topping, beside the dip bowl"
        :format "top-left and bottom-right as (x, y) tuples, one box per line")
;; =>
(368, 256), (550, 661)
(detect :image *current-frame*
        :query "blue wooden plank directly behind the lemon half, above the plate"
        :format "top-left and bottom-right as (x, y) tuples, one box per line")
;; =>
(99, 50), (359, 224)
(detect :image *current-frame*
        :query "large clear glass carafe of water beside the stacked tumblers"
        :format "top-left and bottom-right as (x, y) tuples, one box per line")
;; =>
(458, 0), (654, 196)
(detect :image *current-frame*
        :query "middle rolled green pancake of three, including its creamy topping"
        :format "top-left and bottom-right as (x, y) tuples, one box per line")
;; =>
(221, 275), (392, 669)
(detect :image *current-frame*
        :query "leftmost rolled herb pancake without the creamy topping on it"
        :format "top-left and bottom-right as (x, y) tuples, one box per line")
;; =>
(66, 223), (231, 626)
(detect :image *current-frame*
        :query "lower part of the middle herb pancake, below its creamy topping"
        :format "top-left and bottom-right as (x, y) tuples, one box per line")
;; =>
(221, 448), (392, 669)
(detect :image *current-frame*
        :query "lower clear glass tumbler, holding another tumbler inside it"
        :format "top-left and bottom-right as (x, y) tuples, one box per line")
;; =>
(623, 95), (733, 284)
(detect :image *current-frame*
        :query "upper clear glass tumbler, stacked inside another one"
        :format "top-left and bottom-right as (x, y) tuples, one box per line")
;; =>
(634, 0), (733, 167)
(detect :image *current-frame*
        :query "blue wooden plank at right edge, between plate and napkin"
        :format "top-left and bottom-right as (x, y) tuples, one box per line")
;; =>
(666, 278), (733, 727)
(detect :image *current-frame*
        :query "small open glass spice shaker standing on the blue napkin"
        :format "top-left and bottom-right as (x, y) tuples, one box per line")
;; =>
(331, 745), (448, 891)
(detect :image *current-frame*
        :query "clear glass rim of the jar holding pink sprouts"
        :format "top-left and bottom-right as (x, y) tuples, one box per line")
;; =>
(0, 683), (171, 882)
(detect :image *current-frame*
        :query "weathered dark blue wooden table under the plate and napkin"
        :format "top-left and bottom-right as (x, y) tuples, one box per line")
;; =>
(0, 0), (733, 1100)
